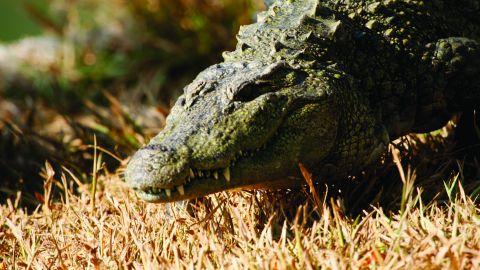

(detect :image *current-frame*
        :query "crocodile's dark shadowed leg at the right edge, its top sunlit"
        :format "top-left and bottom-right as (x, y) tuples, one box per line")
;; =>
(412, 37), (480, 133)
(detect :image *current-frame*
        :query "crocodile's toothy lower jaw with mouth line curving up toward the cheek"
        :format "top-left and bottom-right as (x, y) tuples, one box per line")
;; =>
(127, 97), (326, 203)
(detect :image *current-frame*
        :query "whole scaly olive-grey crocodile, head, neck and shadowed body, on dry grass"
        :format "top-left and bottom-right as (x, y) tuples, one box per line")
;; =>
(124, 0), (480, 203)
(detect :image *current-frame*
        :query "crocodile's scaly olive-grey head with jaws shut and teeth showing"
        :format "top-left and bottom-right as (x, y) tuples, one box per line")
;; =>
(125, 61), (338, 202)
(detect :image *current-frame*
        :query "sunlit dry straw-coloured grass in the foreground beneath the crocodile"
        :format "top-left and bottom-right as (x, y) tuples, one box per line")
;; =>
(0, 140), (480, 269)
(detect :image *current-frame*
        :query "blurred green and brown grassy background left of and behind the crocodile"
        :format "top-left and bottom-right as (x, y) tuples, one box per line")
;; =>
(0, 0), (264, 205)
